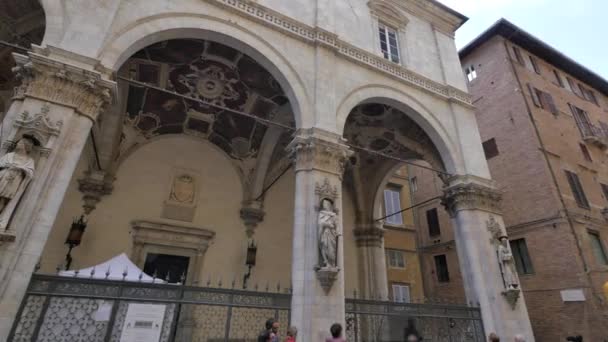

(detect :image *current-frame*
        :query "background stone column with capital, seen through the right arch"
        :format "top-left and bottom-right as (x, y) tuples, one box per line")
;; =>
(355, 221), (388, 300)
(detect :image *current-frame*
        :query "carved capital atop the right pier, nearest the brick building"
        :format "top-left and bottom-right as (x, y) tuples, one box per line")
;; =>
(441, 176), (502, 217)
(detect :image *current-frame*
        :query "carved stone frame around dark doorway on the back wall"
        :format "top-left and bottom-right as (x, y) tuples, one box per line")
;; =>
(131, 220), (215, 285)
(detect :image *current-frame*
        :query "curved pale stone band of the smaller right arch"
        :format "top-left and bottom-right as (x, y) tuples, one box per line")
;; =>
(336, 84), (461, 174)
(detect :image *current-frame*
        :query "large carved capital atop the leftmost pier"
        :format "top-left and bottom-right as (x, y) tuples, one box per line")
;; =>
(13, 52), (116, 121)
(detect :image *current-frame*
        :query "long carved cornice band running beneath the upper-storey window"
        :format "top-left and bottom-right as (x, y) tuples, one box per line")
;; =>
(205, 0), (473, 108)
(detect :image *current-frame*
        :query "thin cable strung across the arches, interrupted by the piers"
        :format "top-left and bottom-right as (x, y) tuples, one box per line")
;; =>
(0, 40), (451, 176)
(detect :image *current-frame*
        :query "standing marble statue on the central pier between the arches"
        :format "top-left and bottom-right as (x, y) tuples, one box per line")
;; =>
(318, 198), (339, 267)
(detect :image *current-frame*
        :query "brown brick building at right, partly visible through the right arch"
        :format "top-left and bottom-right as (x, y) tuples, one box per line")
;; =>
(411, 19), (608, 342)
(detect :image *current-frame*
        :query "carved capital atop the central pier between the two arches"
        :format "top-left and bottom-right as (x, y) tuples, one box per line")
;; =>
(287, 128), (353, 177)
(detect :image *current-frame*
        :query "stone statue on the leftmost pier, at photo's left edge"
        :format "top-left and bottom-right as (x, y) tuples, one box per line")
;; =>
(0, 136), (35, 229)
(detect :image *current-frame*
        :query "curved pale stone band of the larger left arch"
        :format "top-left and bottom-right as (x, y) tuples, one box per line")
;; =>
(98, 13), (314, 128)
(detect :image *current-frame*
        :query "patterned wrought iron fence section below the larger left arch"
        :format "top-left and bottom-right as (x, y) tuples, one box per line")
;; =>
(9, 275), (291, 342)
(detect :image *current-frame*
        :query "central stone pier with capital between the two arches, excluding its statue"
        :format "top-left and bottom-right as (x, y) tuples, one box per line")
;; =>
(288, 128), (351, 341)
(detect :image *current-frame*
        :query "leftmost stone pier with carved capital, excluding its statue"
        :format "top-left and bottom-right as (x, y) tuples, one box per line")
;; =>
(0, 53), (115, 341)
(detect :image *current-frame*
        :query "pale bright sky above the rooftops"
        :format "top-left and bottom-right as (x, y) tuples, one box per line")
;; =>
(439, 0), (608, 80)
